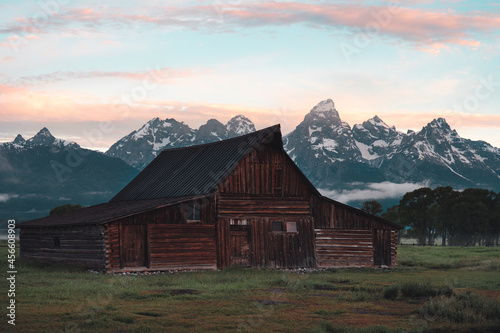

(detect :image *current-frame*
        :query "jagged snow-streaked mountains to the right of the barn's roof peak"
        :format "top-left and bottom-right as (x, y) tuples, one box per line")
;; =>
(284, 99), (500, 190)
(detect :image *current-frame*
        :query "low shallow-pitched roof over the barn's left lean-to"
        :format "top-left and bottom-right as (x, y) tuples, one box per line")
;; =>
(18, 196), (209, 228)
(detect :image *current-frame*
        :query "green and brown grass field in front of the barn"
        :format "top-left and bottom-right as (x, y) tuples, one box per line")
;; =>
(0, 246), (500, 332)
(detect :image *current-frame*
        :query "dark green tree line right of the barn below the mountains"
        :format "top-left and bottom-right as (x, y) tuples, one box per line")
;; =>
(362, 186), (500, 246)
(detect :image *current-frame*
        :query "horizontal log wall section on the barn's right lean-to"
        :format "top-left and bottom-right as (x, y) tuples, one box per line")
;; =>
(314, 229), (373, 268)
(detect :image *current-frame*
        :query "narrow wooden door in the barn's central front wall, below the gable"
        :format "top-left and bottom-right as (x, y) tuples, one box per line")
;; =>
(229, 225), (251, 267)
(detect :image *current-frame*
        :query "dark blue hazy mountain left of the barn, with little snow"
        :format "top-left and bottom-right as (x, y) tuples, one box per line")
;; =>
(0, 128), (139, 222)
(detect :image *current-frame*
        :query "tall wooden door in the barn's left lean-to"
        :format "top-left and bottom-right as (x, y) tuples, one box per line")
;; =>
(120, 224), (146, 268)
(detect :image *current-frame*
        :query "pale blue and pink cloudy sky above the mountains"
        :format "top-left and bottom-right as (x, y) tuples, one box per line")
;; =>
(0, 0), (500, 151)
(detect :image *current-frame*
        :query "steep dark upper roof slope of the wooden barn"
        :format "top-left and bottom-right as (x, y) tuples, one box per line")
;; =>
(111, 124), (298, 202)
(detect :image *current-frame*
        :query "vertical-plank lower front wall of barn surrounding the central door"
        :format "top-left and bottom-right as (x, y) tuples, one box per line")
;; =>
(217, 217), (316, 268)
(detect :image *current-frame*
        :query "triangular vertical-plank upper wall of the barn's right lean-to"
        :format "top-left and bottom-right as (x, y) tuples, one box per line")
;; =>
(312, 196), (393, 230)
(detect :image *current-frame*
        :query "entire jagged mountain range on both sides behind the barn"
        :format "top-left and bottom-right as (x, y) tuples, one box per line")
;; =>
(0, 99), (500, 222)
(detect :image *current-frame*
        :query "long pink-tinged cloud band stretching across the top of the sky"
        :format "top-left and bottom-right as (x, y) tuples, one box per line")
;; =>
(0, 2), (500, 52)
